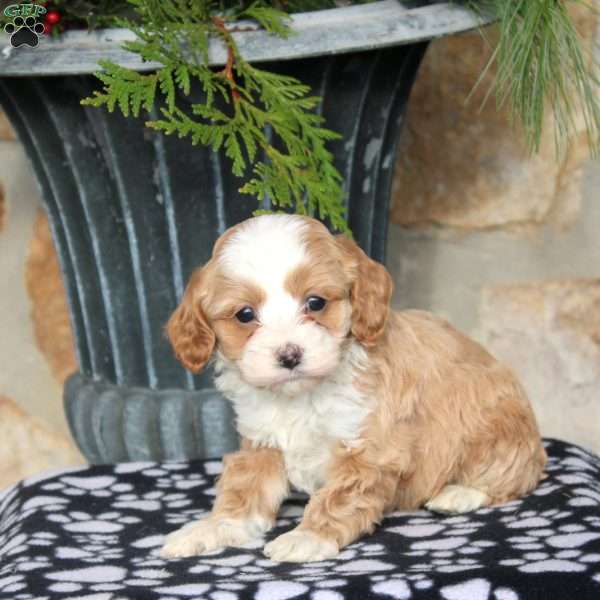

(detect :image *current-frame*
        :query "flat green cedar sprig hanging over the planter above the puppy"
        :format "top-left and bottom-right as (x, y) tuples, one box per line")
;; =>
(82, 0), (349, 232)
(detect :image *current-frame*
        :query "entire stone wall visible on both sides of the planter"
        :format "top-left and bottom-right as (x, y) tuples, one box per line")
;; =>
(0, 9), (600, 489)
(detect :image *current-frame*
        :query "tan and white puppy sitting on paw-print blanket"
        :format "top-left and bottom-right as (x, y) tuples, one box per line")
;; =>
(161, 215), (546, 562)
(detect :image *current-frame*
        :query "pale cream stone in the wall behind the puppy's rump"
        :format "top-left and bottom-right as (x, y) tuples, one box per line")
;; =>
(481, 278), (600, 450)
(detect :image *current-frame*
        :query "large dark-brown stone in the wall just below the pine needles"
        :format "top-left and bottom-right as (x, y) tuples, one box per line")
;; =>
(391, 3), (596, 231)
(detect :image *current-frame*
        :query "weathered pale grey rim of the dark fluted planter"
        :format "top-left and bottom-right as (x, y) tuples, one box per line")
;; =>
(0, 0), (494, 77)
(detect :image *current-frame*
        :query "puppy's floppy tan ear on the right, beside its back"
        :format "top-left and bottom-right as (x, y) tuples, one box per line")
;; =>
(335, 235), (394, 346)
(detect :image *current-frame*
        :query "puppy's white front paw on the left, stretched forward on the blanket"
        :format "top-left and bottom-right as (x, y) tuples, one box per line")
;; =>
(160, 517), (257, 558)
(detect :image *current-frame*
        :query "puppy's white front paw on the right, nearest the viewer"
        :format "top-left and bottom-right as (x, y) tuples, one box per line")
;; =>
(264, 529), (339, 562)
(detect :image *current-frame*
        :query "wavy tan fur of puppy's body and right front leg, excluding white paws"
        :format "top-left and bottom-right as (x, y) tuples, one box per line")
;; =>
(301, 311), (546, 547)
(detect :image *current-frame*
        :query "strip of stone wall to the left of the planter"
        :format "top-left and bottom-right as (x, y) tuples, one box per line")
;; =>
(0, 125), (84, 489)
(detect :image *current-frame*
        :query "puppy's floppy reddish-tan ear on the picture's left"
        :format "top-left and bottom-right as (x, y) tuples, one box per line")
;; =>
(166, 267), (216, 373)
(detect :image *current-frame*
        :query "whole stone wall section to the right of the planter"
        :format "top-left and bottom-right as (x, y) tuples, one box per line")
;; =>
(388, 4), (600, 452)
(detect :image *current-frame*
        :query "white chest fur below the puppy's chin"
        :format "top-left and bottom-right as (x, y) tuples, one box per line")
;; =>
(216, 344), (372, 494)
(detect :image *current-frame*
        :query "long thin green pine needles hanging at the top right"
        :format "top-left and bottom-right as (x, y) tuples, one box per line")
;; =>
(468, 0), (600, 155)
